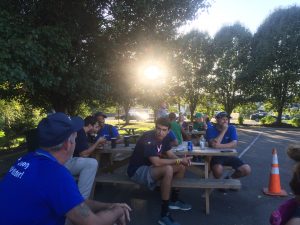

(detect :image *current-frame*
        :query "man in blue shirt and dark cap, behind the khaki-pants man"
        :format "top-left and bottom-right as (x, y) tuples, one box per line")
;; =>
(94, 112), (122, 143)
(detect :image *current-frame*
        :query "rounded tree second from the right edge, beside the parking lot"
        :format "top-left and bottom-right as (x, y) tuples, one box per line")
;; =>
(209, 24), (252, 114)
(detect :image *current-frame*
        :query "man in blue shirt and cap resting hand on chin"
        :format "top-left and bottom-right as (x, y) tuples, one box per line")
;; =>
(206, 112), (251, 178)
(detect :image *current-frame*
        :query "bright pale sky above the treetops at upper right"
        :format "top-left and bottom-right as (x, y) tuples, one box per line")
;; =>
(179, 0), (300, 37)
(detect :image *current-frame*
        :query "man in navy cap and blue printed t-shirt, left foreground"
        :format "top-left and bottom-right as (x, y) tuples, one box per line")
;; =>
(0, 113), (131, 225)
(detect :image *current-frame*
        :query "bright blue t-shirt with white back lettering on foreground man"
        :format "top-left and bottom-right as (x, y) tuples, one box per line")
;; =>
(0, 149), (84, 225)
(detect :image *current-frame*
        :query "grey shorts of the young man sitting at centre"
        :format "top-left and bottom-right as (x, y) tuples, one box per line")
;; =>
(130, 166), (157, 191)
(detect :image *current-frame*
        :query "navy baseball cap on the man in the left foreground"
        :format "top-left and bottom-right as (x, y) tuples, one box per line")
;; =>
(37, 112), (84, 147)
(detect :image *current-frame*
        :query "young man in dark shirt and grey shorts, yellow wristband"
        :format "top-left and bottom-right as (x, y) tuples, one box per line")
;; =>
(127, 118), (191, 225)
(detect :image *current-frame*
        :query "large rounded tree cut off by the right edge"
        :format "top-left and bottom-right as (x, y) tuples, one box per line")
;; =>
(251, 6), (300, 124)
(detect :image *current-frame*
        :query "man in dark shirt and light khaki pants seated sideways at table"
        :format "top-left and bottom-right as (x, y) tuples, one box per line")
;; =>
(65, 116), (106, 199)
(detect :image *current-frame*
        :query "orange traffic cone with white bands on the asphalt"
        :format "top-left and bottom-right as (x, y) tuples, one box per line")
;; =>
(263, 148), (287, 196)
